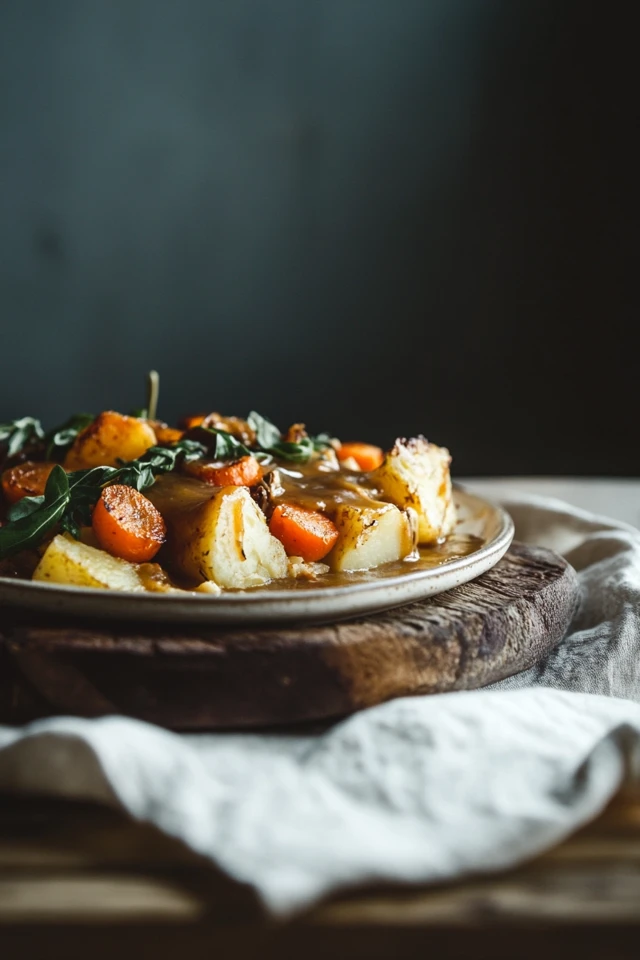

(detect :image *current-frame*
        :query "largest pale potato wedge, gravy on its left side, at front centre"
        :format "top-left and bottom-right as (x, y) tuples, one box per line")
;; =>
(145, 474), (288, 589)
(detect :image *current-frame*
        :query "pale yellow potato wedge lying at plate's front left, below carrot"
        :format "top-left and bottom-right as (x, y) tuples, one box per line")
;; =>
(33, 534), (144, 592)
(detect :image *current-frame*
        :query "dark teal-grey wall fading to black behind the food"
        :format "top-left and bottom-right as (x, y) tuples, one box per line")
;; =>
(0, 0), (640, 475)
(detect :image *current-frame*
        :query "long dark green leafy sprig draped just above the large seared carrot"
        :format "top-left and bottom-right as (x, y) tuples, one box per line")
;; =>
(0, 440), (205, 559)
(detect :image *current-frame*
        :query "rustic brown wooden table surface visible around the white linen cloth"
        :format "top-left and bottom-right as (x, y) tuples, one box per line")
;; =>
(0, 480), (640, 960)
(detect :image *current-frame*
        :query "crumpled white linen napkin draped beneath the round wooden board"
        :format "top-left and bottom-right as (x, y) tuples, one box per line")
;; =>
(0, 497), (640, 916)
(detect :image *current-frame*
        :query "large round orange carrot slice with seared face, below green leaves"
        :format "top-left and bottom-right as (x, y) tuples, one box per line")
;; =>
(93, 483), (167, 563)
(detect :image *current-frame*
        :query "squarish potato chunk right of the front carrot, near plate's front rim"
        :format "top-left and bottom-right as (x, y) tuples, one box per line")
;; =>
(325, 503), (417, 571)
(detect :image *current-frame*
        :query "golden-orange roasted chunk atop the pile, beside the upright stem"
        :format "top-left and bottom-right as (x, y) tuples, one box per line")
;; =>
(64, 410), (156, 470)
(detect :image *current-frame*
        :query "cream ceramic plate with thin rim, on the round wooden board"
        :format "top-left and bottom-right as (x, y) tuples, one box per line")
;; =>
(0, 488), (513, 626)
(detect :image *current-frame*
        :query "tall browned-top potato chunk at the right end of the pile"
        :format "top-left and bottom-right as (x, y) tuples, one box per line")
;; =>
(370, 437), (456, 544)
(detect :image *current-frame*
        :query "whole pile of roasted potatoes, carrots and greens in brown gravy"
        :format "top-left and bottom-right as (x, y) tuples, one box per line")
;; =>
(0, 396), (455, 594)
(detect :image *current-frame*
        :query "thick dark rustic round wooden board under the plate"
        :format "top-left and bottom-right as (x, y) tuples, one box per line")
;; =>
(0, 543), (578, 730)
